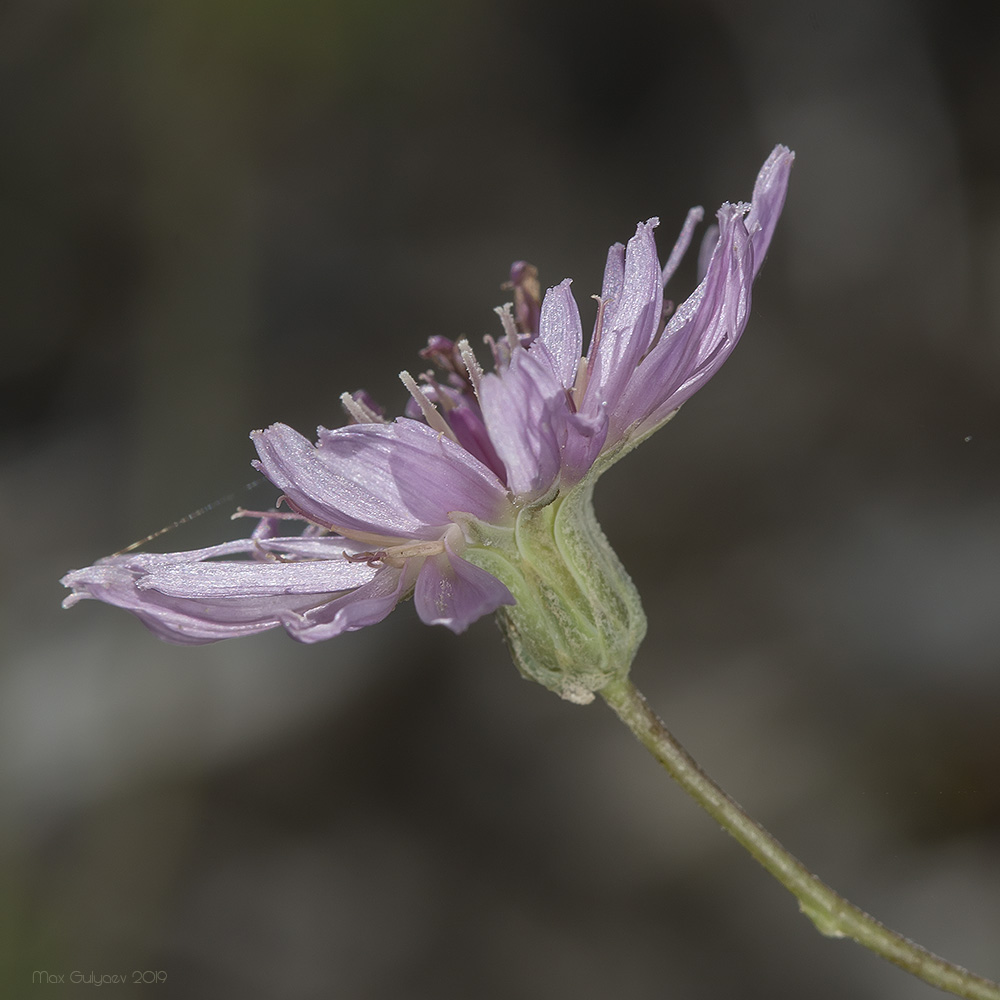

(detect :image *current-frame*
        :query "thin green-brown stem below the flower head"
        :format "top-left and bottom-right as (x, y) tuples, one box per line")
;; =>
(600, 678), (1000, 1000)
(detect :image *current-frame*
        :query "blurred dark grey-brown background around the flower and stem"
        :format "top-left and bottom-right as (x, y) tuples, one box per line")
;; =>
(0, 0), (1000, 1000)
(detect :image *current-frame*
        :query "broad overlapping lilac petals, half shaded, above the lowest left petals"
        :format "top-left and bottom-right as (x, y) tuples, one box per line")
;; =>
(251, 418), (507, 539)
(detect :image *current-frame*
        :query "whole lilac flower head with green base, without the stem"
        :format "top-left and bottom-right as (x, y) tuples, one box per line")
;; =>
(62, 146), (794, 701)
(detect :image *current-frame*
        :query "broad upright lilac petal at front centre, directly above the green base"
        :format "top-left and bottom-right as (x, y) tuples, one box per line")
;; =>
(479, 350), (569, 501)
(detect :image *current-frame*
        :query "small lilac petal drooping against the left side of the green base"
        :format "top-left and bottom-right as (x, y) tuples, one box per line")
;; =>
(413, 548), (515, 634)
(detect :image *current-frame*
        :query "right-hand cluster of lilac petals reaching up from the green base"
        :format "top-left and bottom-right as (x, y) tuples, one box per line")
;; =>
(479, 146), (794, 499)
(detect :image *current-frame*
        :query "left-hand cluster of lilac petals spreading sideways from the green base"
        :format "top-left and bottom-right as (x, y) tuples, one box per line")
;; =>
(63, 418), (513, 643)
